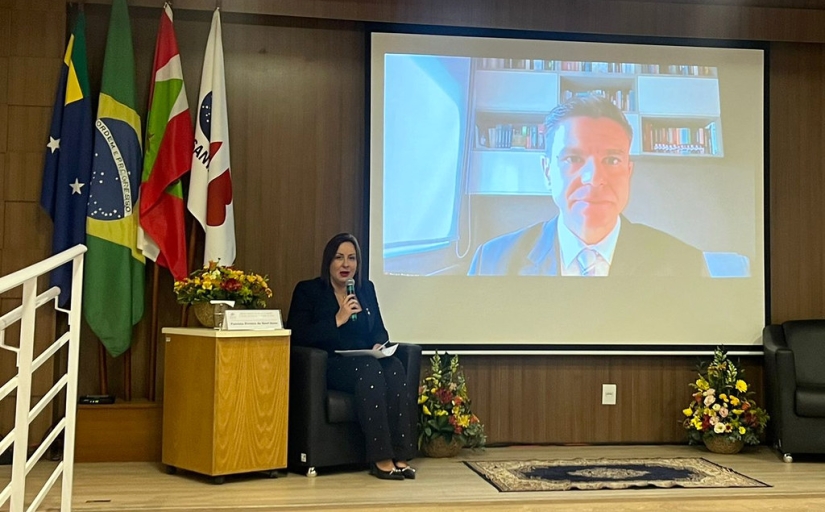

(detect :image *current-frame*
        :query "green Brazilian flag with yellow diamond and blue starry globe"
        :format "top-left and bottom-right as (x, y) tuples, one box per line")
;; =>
(83, 0), (145, 357)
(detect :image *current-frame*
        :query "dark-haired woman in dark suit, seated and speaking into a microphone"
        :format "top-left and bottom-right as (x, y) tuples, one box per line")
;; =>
(287, 233), (416, 480)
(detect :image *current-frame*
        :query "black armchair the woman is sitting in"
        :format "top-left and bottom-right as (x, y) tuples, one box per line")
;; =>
(288, 344), (421, 476)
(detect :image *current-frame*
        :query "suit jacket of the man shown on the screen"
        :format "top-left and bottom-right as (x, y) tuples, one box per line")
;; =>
(468, 216), (708, 277)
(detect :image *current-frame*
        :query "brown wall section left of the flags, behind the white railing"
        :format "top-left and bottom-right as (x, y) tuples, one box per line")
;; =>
(0, 0), (66, 443)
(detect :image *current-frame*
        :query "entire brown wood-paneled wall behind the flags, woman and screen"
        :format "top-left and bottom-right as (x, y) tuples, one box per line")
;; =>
(6, 0), (825, 443)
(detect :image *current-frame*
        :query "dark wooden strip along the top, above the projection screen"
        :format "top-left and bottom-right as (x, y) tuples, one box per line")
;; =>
(88, 0), (825, 42)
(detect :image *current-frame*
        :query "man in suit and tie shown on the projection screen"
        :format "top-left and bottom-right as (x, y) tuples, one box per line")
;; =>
(469, 96), (707, 276)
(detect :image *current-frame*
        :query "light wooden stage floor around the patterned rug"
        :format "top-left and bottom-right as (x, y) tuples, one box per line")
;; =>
(0, 446), (825, 512)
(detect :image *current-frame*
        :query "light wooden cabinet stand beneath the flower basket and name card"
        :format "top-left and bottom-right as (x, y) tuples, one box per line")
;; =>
(161, 327), (290, 483)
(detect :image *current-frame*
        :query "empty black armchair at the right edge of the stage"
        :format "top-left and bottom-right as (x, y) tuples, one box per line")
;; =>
(762, 320), (825, 462)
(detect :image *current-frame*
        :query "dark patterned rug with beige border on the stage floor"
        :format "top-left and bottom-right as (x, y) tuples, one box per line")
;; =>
(465, 457), (770, 492)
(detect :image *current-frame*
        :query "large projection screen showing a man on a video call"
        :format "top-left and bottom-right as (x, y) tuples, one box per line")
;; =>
(368, 32), (766, 352)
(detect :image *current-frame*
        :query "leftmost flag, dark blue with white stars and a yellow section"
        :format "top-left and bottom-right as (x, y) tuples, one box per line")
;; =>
(40, 12), (94, 306)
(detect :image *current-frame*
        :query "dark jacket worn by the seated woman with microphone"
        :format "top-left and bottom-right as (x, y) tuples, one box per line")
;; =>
(287, 277), (390, 352)
